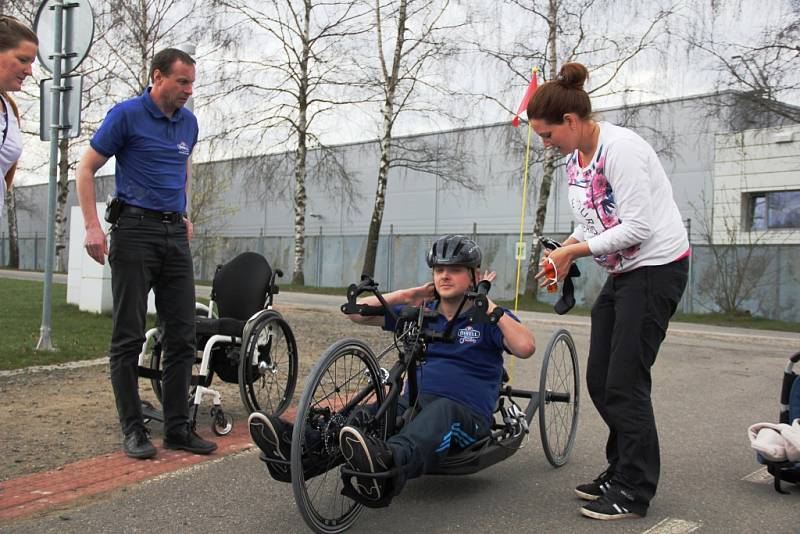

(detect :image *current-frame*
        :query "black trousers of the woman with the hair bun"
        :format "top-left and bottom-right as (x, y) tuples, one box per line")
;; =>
(586, 259), (689, 509)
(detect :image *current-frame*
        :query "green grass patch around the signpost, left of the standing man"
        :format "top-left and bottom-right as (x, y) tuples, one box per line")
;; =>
(0, 278), (153, 370)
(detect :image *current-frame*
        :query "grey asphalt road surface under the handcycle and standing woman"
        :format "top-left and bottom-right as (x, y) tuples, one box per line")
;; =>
(0, 314), (800, 533)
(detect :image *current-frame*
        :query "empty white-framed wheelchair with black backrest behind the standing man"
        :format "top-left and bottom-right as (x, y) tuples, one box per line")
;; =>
(139, 252), (298, 436)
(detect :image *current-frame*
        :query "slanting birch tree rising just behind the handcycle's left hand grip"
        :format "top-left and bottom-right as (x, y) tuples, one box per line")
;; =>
(362, 0), (479, 275)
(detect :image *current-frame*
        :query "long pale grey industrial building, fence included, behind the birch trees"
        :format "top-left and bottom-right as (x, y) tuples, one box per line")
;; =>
(0, 92), (800, 321)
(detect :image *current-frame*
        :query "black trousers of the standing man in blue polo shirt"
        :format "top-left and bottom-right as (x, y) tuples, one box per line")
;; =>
(108, 213), (196, 440)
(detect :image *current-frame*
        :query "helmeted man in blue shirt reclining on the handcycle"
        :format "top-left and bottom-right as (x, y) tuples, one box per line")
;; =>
(249, 235), (536, 506)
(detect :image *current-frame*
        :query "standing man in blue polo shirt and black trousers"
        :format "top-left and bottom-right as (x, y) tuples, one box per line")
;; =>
(76, 48), (217, 458)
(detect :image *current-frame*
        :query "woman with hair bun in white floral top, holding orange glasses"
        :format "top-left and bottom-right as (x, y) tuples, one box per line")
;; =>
(527, 63), (690, 519)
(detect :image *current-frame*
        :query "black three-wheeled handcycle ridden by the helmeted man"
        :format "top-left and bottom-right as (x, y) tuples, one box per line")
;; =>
(282, 277), (580, 533)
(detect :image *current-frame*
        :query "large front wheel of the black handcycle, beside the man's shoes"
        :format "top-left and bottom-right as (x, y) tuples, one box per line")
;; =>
(291, 339), (386, 533)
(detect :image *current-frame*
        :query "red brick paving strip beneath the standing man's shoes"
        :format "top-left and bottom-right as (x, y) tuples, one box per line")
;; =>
(0, 428), (253, 522)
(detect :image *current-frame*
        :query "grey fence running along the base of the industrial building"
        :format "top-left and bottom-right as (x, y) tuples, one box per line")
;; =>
(0, 233), (800, 322)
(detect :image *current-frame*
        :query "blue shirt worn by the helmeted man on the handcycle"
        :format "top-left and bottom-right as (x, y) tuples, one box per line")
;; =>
(383, 302), (519, 421)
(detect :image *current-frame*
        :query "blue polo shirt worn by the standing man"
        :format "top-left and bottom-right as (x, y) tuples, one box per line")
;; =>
(90, 87), (198, 213)
